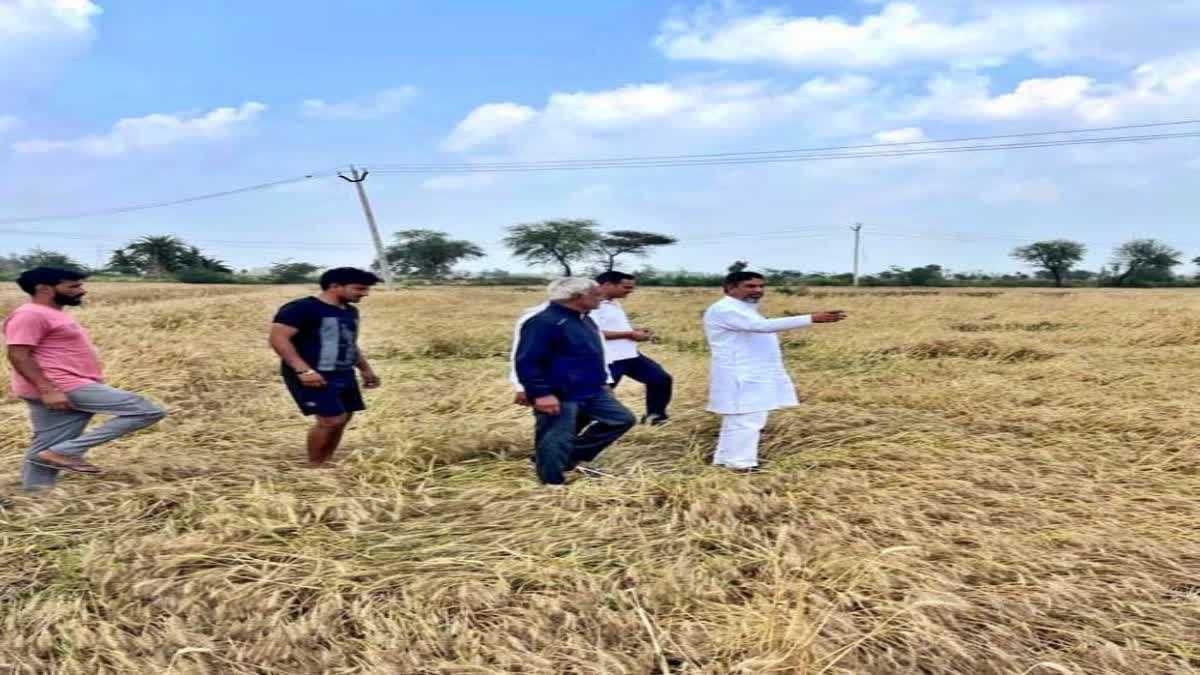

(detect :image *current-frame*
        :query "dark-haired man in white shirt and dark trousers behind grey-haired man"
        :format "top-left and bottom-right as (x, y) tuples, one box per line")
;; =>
(590, 271), (674, 426)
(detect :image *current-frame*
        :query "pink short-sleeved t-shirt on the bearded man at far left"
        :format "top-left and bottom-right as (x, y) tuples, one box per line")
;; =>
(4, 303), (104, 399)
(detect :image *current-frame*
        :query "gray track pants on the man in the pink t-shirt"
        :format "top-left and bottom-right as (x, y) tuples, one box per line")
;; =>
(22, 384), (167, 490)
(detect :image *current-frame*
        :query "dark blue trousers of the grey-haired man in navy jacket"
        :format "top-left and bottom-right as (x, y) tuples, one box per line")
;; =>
(534, 392), (637, 485)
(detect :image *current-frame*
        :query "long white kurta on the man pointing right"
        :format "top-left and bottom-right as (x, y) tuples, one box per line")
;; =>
(704, 297), (812, 414)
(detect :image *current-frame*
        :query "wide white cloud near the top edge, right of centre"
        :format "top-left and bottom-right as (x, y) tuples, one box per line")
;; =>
(654, 2), (1086, 67)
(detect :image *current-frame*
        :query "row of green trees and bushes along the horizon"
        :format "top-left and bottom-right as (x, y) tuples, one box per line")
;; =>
(0, 220), (1200, 287)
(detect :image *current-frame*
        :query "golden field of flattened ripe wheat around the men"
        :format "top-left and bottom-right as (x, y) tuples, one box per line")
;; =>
(0, 285), (1200, 675)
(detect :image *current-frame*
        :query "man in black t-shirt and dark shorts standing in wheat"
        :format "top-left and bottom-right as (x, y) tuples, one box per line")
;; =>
(270, 267), (379, 468)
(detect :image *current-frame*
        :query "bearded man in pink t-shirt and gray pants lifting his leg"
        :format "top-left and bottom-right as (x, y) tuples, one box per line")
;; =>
(4, 267), (167, 490)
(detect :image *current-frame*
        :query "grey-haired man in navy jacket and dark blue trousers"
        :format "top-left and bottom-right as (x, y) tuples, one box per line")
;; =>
(515, 277), (637, 485)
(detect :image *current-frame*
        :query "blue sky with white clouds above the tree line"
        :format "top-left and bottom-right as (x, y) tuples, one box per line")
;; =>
(0, 0), (1200, 271)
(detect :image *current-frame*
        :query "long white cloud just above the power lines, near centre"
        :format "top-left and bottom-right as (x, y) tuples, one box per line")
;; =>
(445, 76), (875, 151)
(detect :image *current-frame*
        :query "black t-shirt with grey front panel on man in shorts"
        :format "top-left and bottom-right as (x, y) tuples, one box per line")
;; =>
(275, 298), (359, 372)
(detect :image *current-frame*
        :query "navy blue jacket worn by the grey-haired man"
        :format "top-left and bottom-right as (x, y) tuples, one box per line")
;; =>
(515, 303), (608, 401)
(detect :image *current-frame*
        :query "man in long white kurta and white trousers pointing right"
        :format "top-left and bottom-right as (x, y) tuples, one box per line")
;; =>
(704, 271), (846, 472)
